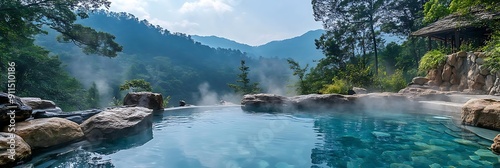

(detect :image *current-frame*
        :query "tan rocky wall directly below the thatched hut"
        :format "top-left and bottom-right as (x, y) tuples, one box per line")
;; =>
(427, 51), (500, 95)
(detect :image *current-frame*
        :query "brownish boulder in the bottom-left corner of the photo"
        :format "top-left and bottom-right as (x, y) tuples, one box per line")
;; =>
(0, 132), (31, 167)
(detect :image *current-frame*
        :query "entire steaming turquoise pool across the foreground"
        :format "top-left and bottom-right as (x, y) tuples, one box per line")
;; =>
(26, 107), (500, 168)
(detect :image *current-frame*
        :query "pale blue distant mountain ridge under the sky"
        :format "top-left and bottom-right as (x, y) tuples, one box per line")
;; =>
(191, 29), (325, 65)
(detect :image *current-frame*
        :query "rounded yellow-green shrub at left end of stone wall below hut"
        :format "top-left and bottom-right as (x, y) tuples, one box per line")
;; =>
(418, 50), (447, 72)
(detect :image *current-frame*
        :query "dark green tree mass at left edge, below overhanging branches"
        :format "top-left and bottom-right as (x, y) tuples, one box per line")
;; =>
(0, 44), (87, 111)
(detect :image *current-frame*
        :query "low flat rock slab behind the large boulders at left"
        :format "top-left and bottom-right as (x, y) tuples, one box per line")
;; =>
(33, 109), (103, 124)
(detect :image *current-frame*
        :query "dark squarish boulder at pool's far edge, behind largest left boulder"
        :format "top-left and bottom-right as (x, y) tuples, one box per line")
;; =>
(123, 92), (163, 110)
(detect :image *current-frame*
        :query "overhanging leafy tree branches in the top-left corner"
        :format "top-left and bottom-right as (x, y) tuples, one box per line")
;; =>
(0, 0), (122, 57)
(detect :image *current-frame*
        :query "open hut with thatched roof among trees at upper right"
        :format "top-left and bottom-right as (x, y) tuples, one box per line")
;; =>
(411, 10), (500, 51)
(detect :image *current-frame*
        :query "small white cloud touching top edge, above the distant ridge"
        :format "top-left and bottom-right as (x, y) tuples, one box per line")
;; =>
(179, 0), (233, 13)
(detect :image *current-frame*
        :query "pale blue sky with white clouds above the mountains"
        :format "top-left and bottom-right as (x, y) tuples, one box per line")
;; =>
(110, 0), (322, 46)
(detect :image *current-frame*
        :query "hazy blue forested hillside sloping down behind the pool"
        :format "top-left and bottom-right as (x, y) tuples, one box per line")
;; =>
(30, 11), (290, 109)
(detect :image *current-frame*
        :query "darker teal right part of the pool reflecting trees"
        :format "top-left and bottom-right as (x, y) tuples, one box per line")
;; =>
(311, 110), (500, 168)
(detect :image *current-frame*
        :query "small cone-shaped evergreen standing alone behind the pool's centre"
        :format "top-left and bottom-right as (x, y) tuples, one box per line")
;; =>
(228, 60), (260, 94)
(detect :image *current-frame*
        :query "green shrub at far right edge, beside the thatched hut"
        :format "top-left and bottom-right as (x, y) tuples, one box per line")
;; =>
(483, 30), (500, 72)
